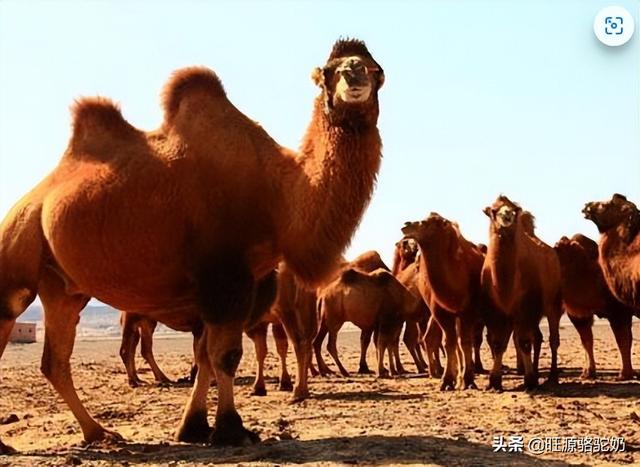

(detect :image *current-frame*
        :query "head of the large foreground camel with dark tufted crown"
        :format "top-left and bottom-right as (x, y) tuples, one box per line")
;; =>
(311, 39), (384, 124)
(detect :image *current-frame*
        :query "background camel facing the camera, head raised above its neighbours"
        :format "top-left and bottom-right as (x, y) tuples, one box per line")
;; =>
(481, 195), (562, 391)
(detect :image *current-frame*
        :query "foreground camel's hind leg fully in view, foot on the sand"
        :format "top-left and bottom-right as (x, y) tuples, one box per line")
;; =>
(38, 270), (120, 443)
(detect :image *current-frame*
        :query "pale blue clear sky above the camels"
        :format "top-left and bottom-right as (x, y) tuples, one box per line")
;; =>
(0, 0), (640, 270)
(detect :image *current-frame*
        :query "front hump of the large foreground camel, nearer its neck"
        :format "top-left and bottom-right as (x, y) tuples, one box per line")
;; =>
(162, 66), (227, 122)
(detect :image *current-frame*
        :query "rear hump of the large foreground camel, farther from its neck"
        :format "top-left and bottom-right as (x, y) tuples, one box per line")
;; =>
(71, 97), (138, 154)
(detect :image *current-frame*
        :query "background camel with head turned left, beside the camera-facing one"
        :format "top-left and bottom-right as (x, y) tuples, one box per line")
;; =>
(402, 212), (483, 390)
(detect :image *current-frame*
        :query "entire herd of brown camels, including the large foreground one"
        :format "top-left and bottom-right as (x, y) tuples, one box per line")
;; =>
(0, 39), (640, 454)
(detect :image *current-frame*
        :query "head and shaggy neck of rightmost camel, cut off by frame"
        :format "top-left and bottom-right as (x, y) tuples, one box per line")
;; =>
(582, 193), (640, 310)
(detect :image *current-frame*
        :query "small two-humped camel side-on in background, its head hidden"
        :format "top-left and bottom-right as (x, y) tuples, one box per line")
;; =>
(313, 268), (417, 377)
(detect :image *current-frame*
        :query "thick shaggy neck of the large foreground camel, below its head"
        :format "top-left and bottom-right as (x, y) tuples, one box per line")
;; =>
(284, 99), (382, 283)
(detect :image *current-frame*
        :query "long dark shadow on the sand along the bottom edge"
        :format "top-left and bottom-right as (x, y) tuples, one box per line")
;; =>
(28, 435), (586, 467)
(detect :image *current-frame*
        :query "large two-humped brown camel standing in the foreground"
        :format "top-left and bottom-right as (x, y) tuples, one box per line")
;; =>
(0, 39), (384, 450)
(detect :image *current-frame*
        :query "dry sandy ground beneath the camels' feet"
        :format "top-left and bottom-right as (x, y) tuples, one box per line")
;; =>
(0, 324), (640, 466)
